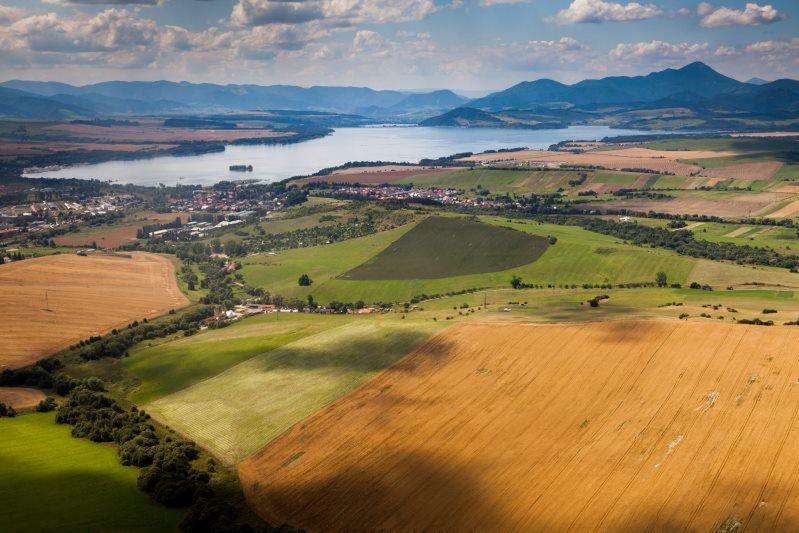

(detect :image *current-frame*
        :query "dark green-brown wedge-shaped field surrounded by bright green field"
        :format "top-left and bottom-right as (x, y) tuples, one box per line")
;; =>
(341, 217), (548, 280)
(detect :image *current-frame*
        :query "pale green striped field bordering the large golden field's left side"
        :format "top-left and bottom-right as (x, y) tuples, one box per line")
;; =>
(150, 315), (443, 461)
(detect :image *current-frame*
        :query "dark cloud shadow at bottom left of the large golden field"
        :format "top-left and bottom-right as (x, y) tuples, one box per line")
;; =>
(245, 450), (511, 531)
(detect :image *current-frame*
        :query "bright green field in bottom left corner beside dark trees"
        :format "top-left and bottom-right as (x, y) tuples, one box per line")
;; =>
(0, 413), (183, 533)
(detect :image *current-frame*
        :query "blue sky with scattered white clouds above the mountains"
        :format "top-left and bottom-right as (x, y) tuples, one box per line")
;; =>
(0, 0), (799, 91)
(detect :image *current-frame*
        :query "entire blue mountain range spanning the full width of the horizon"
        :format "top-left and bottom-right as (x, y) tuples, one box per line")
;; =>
(0, 62), (799, 129)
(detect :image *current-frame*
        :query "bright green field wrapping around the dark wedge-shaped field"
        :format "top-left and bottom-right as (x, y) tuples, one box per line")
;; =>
(242, 213), (695, 304)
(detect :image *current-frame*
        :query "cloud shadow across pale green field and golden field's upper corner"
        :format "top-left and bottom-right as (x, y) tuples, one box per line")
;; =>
(248, 331), (453, 372)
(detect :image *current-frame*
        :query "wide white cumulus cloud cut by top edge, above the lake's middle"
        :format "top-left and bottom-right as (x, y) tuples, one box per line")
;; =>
(230, 0), (438, 26)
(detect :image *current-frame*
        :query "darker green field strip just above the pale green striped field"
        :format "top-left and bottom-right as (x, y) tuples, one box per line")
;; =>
(123, 313), (347, 403)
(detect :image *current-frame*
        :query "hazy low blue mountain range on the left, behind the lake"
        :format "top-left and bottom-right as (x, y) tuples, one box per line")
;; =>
(0, 80), (467, 121)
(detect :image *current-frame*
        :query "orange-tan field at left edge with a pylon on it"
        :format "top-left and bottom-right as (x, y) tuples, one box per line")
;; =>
(0, 253), (188, 369)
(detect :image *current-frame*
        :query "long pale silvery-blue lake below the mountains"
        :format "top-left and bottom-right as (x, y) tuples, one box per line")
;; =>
(26, 126), (657, 185)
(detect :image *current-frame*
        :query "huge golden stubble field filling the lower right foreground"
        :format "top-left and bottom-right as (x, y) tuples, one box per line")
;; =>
(239, 320), (799, 531)
